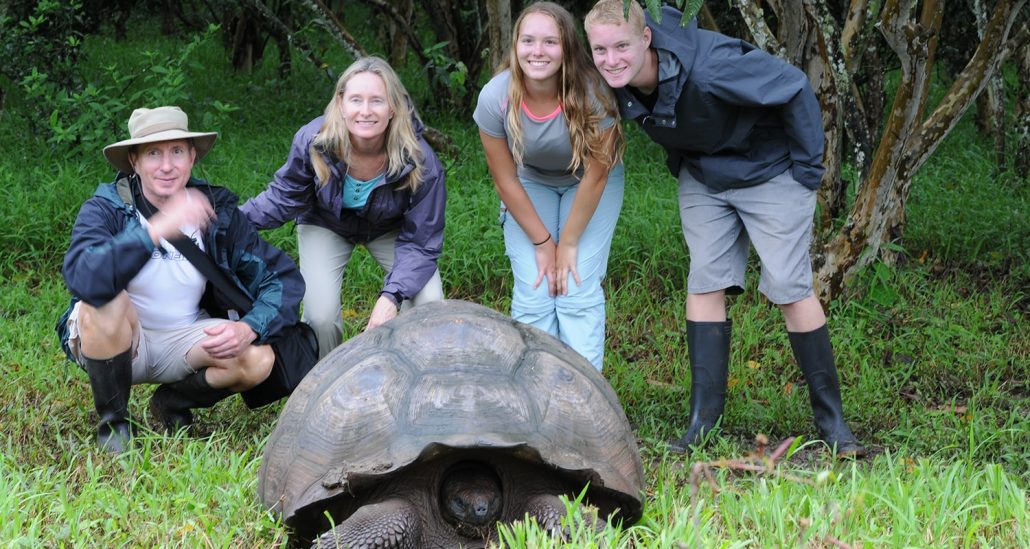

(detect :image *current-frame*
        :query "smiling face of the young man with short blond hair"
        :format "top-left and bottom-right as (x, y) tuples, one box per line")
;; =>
(586, 23), (657, 90)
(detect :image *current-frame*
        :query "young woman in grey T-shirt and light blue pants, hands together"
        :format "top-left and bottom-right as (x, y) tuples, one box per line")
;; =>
(473, 2), (624, 370)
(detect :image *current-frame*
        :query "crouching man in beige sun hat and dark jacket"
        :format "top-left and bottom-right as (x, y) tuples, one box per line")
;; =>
(58, 107), (304, 453)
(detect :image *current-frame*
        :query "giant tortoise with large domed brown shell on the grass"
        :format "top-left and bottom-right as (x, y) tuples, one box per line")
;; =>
(258, 301), (644, 548)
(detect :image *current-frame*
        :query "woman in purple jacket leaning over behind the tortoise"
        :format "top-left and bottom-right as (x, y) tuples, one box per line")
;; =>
(247, 57), (447, 356)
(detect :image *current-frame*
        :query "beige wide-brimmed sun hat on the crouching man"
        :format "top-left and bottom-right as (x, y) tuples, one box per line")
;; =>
(104, 107), (218, 173)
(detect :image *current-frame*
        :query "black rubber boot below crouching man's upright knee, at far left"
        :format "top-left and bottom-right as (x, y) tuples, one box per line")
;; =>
(81, 349), (132, 454)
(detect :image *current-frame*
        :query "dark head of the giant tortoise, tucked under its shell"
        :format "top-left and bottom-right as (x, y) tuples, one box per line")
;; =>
(440, 461), (502, 538)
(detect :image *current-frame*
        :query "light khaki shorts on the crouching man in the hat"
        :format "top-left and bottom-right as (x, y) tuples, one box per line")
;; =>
(68, 303), (229, 384)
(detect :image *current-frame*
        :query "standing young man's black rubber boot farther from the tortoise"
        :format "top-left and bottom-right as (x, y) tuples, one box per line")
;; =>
(787, 324), (867, 457)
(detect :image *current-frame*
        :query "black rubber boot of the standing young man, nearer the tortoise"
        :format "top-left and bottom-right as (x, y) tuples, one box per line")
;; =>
(670, 320), (733, 452)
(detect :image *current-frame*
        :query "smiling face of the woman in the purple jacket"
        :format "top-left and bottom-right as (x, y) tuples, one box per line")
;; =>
(340, 72), (393, 145)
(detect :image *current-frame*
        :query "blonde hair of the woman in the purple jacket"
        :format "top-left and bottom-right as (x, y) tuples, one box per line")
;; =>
(311, 56), (425, 191)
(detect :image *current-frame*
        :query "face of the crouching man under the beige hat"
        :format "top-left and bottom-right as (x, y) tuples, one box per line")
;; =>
(129, 139), (197, 206)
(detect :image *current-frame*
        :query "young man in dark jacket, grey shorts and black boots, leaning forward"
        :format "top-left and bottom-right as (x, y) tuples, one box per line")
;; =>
(584, 0), (866, 455)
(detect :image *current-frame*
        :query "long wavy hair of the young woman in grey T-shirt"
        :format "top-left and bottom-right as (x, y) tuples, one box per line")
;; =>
(497, 2), (625, 174)
